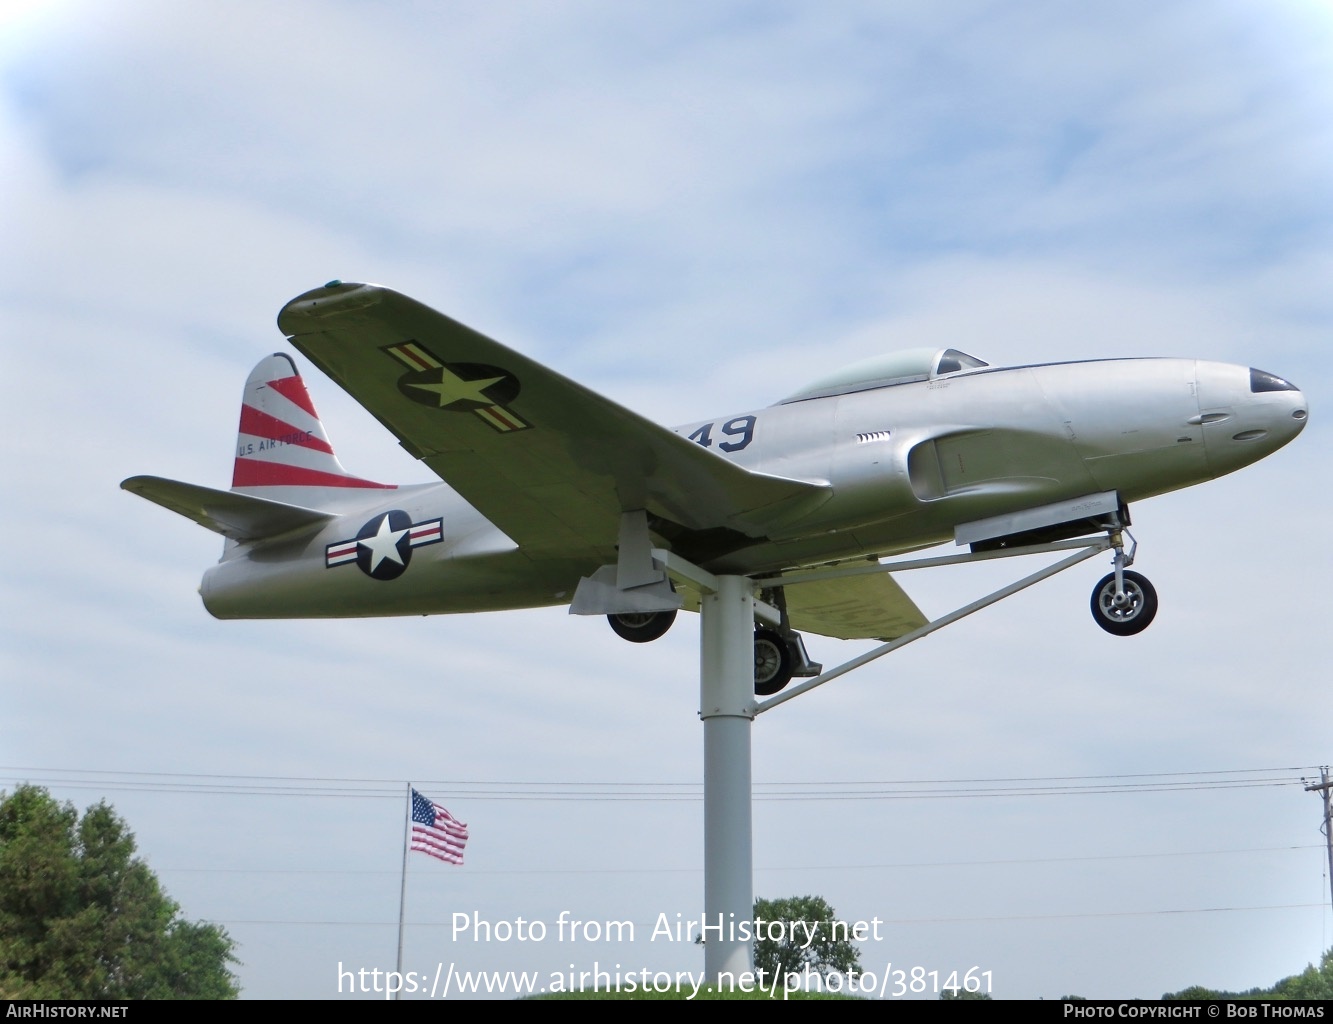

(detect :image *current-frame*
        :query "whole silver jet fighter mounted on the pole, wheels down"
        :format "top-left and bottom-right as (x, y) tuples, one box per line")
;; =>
(121, 281), (1308, 693)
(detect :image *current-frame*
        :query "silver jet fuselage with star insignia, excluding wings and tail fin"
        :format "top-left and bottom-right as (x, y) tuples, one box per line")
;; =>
(200, 359), (1308, 619)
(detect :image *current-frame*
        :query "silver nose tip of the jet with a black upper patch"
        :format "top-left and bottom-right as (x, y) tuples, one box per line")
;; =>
(1198, 363), (1309, 476)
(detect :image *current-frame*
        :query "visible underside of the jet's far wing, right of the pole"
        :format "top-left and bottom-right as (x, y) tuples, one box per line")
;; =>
(784, 572), (928, 640)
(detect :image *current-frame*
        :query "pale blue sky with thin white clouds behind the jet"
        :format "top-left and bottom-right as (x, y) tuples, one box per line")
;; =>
(0, 0), (1333, 999)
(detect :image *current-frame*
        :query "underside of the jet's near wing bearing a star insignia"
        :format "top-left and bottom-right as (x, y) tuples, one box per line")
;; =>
(279, 283), (829, 559)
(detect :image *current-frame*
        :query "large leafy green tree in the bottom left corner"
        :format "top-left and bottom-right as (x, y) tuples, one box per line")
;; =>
(0, 785), (239, 999)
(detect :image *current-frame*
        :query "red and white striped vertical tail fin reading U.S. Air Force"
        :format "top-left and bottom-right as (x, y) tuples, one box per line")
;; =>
(232, 352), (393, 500)
